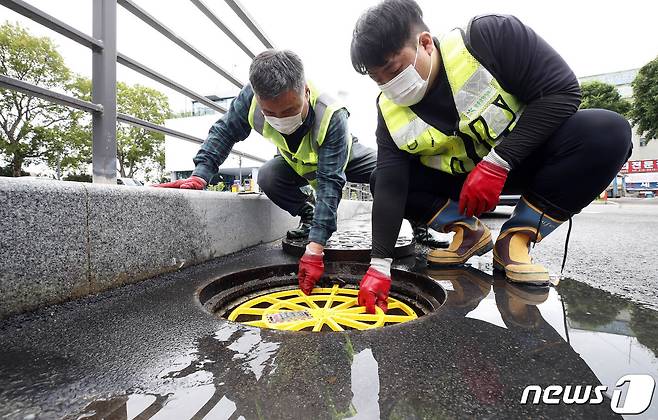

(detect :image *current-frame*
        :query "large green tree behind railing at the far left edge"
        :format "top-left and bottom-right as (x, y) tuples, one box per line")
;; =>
(0, 22), (81, 176)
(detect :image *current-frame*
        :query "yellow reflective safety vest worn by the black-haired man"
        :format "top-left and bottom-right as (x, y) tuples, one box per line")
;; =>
(378, 29), (525, 174)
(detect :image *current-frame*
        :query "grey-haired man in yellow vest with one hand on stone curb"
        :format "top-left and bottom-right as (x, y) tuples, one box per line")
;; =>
(159, 50), (377, 294)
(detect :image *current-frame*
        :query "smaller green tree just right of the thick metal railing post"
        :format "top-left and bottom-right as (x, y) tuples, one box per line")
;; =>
(73, 78), (171, 178)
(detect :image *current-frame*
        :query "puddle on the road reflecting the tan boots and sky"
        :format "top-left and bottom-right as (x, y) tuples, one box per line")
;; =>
(427, 267), (658, 418)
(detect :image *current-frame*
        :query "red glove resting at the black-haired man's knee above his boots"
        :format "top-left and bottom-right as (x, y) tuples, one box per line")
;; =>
(459, 160), (507, 217)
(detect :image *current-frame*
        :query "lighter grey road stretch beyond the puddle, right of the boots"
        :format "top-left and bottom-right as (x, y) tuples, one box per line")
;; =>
(484, 200), (658, 310)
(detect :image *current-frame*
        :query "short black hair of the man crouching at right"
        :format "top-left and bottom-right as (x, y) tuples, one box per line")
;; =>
(350, 0), (429, 74)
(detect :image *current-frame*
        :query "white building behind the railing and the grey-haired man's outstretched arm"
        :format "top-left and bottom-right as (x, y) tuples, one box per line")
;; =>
(165, 96), (276, 189)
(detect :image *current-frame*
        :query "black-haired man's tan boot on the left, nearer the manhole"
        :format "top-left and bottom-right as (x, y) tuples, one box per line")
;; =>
(427, 218), (493, 266)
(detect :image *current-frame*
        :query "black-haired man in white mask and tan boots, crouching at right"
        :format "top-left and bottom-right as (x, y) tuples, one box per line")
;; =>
(351, 0), (632, 312)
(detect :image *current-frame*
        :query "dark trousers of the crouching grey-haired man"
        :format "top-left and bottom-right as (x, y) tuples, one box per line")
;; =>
(258, 143), (377, 216)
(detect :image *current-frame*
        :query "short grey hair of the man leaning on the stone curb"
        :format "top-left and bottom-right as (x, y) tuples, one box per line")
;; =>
(249, 50), (306, 99)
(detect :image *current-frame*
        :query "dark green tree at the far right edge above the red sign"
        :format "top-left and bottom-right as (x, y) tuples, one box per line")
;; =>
(631, 57), (658, 140)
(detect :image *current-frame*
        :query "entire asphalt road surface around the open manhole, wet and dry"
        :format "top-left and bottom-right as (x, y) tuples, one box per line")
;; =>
(0, 199), (658, 419)
